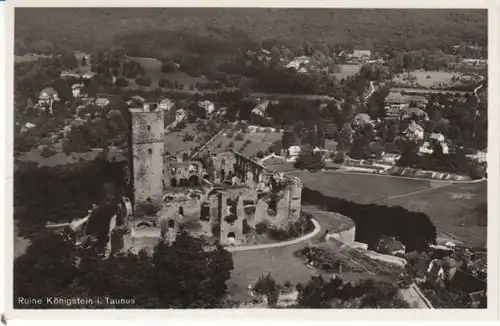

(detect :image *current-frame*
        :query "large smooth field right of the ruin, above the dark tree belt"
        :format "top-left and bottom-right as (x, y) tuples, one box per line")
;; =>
(293, 171), (487, 247)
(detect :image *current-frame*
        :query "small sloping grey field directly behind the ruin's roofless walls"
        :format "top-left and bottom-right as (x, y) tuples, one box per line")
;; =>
(203, 127), (281, 157)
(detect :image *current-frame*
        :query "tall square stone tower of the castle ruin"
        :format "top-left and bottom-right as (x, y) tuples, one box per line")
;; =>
(129, 109), (164, 211)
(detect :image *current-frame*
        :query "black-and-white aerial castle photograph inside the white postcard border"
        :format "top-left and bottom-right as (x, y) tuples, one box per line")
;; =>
(5, 3), (498, 318)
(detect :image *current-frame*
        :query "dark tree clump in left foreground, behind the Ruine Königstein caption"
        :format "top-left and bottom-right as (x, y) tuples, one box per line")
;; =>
(14, 231), (234, 309)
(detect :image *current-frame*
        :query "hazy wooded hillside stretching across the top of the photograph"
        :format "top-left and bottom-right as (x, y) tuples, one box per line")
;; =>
(15, 8), (487, 52)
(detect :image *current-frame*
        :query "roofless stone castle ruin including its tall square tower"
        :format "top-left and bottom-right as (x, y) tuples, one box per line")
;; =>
(112, 108), (302, 251)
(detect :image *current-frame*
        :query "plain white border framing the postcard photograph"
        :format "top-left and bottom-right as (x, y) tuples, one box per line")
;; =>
(0, 0), (500, 324)
